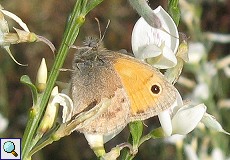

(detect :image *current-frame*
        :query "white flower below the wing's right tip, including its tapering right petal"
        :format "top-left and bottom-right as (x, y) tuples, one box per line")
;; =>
(158, 92), (230, 136)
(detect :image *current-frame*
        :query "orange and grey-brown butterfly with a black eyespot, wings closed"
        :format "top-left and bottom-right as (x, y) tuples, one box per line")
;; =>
(71, 37), (176, 135)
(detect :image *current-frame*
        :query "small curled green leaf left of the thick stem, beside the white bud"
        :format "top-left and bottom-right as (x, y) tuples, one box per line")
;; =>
(20, 75), (38, 104)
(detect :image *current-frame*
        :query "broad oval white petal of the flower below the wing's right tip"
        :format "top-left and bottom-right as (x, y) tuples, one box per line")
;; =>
(172, 104), (207, 135)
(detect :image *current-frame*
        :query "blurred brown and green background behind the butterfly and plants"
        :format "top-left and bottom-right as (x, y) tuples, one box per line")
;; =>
(0, 0), (230, 160)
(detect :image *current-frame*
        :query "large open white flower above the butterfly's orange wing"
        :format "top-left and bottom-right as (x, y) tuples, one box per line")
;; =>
(132, 6), (179, 69)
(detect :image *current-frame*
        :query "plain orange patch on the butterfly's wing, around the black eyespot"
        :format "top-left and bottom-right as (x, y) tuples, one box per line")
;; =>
(114, 58), (162, 115)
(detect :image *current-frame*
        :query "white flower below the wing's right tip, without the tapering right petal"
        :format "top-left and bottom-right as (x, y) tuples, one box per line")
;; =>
(158, 90), (207, 136)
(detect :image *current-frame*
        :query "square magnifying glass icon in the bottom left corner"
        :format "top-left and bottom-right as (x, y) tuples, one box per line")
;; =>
(0, 138), (21, 160)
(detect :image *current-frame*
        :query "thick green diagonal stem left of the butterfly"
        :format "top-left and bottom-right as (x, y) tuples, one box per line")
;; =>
(22, 0), (102, 159)
